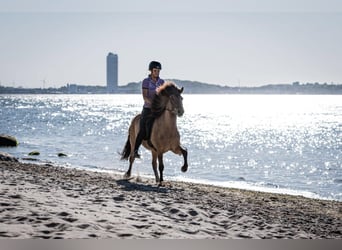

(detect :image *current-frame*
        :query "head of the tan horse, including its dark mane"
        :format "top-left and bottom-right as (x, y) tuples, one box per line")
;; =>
(152, 82), (184, 116)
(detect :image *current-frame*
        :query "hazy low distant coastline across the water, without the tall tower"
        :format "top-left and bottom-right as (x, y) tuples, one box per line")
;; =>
(0, 79), (342, 95)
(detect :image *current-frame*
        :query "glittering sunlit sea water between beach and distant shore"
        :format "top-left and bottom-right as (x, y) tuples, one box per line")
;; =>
(0, 94), (342, 201)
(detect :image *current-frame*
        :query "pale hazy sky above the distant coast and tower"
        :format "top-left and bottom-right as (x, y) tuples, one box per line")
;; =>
(0, 0), (342, 87)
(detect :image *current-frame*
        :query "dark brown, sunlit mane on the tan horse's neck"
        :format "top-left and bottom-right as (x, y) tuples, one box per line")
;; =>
(151, 81), (180, 117)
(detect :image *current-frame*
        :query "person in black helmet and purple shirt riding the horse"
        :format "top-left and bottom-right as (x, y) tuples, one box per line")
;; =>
(134, 61), (164, 158)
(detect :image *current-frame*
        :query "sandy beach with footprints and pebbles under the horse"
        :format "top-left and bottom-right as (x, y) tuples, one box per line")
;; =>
(0, 161), (342, 239)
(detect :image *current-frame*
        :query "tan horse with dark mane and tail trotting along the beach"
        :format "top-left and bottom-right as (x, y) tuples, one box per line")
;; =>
(121, 82), (188, 185)
